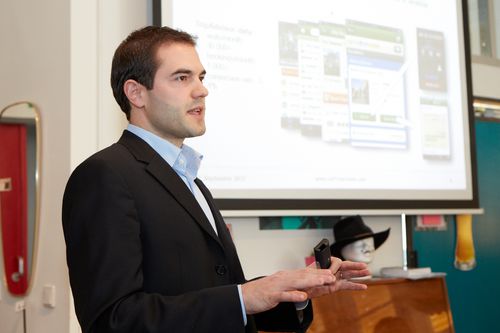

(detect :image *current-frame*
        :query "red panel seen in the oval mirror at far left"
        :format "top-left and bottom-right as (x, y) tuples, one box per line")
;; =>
(0, 124), (28, 295)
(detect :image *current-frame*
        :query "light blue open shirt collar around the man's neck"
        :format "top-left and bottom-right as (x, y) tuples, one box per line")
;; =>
(127, 124), (203, 181)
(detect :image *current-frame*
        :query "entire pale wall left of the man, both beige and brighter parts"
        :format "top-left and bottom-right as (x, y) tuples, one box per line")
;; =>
(0, 0), (150, 333)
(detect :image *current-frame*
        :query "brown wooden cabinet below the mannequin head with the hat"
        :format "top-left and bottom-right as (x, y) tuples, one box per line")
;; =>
(307, 277), (454, 333)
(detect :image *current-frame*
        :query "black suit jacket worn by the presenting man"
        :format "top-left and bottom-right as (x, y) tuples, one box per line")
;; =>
(62, 131), (312, 333)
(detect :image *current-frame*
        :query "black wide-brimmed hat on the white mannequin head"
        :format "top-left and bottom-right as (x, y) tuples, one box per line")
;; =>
(330, 215), (391, 259)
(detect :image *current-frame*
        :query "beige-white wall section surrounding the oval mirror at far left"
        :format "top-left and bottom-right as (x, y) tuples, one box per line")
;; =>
(0, 0), (70, 333)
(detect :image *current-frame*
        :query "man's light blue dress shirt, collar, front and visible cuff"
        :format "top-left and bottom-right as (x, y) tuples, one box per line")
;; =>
(127, 124), (247, 325)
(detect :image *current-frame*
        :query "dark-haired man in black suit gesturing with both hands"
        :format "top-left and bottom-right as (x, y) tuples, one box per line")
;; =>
(63, 27), (369, 333)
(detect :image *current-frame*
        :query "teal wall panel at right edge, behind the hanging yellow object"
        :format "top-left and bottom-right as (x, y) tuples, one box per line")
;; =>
(413, 121), (500, 333)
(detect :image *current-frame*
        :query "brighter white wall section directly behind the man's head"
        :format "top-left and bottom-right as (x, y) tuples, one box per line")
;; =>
(71, 0), (145, 169)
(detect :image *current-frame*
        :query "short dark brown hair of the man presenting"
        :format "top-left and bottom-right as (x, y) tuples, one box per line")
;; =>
(111, 26), (196, 119)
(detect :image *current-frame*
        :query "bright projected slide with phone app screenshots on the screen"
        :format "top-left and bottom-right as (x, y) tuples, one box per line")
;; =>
(162, 0), (472, 200)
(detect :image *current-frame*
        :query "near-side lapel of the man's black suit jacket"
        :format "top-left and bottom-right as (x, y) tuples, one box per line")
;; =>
(118, 131), (222, 246)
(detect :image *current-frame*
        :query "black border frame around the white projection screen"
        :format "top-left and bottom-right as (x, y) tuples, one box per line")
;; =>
(151, 0), (482, 216)
